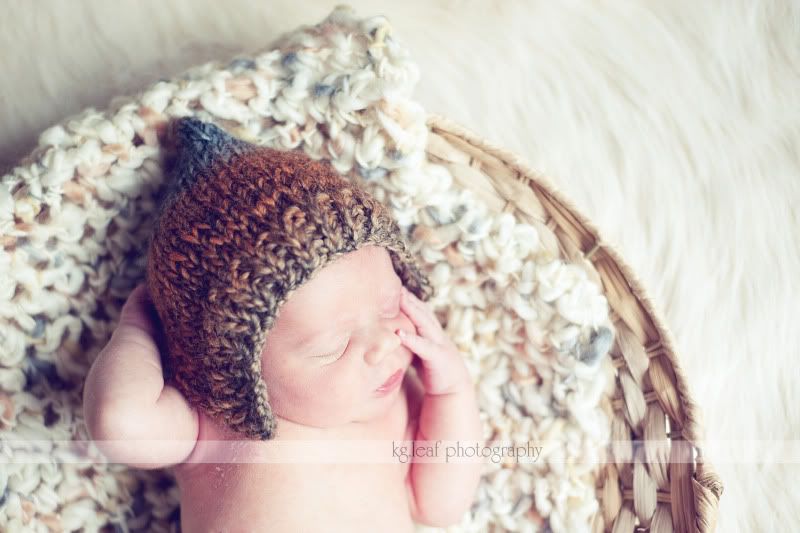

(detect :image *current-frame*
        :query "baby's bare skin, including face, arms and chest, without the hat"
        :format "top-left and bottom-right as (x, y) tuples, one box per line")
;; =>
(84, 246), (482, 533)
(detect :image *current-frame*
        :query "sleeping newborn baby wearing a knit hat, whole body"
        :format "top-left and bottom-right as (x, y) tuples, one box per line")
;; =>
(84, 118), (483, 533)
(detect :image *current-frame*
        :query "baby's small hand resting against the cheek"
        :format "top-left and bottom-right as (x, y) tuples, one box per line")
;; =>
(397, 287), (472, 395)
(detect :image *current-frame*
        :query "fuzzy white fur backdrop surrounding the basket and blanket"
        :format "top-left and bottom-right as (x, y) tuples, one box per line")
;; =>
(0, 0), (800, 532)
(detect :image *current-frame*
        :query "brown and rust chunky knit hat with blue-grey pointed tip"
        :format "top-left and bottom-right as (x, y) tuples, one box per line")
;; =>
(147, 118), (433, 440)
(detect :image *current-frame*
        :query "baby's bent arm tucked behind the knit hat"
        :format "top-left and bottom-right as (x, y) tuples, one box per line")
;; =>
(83, 285), (199, 468)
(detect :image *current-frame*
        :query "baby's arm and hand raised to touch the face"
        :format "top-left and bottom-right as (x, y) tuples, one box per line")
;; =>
(400, 289), (483, 527)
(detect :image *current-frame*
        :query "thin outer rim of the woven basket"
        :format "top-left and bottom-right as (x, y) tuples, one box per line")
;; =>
(426, 112), (723, 531)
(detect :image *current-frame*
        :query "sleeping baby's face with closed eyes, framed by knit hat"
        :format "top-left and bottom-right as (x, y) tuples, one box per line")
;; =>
(262, 246), (415, 431)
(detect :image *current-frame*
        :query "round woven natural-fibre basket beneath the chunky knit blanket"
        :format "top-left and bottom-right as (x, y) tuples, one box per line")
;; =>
(426, 111), (723, 533)
